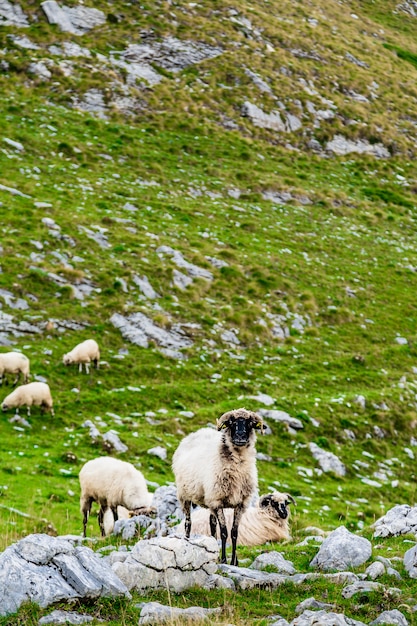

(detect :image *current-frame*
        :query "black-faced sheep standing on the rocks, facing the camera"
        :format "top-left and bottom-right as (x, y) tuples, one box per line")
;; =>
(172, 409), (263, 565)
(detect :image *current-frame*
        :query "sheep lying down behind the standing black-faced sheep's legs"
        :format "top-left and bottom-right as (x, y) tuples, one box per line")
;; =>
(175, 491), (295, 546)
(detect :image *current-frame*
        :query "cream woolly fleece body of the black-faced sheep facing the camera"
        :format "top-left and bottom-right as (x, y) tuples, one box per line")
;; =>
(172, 428), (257, 509)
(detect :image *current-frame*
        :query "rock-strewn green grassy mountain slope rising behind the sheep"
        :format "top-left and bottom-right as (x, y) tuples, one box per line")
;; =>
(0, 0), (417, 620)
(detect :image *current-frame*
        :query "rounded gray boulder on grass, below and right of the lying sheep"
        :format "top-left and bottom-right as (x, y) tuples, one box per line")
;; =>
(310, 526), (372, 571)
